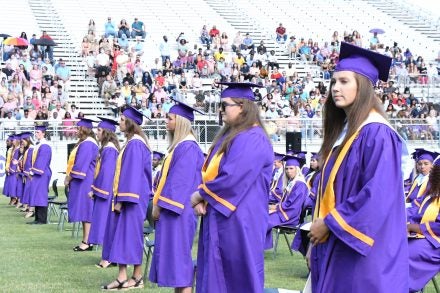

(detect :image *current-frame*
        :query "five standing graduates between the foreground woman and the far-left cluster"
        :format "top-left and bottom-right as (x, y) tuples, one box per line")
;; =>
(65, 83), (273, 292)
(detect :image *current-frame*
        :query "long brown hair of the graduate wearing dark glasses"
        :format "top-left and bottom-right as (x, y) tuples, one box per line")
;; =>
(210, 98), (268, 153)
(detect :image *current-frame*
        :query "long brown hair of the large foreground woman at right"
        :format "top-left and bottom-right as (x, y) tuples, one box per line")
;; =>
(319, 73), (386, 164)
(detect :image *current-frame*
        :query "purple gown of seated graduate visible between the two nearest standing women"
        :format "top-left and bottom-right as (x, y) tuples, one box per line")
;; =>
(264, 180), (309, 249)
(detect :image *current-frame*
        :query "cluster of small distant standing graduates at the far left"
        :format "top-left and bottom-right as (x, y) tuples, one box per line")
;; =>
(3, 126), (52, 224)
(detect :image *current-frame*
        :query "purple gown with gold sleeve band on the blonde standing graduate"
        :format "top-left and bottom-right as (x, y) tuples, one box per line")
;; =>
(150, 141), (204, 288)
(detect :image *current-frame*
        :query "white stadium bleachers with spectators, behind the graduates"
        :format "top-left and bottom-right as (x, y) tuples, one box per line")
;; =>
(0, 0), (440, 149)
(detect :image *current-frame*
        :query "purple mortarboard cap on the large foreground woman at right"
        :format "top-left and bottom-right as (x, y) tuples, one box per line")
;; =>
(335, 42), (392, 85)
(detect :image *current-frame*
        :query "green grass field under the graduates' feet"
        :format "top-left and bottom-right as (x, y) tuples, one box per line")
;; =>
(0, 192), (440, 293)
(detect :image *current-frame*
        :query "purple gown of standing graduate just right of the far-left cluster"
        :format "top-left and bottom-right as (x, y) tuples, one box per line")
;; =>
(67, 137), (98, 222)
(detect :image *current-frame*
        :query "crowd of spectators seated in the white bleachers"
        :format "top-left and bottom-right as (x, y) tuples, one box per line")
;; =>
(0, 17), (440, 140)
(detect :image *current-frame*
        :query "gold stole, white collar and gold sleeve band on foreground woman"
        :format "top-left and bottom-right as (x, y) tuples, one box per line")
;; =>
(314, 111), (393, 246)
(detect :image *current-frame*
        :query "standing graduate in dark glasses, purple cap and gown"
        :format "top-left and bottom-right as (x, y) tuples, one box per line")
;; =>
(191, 83), (274, 293)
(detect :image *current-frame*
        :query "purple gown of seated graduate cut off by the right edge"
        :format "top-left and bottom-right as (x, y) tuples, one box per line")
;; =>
(408, 197), (440, 292)
